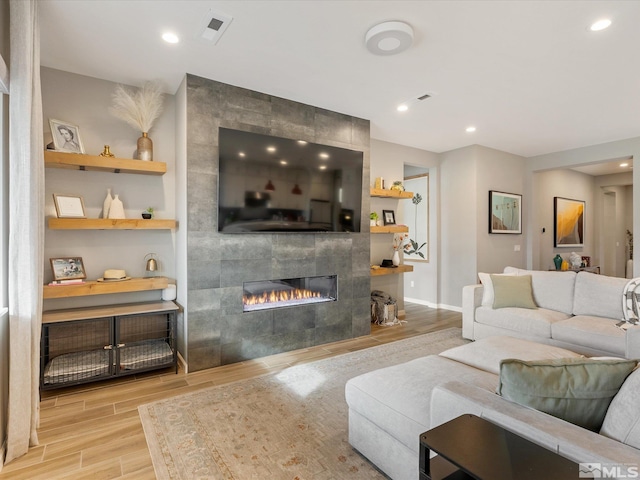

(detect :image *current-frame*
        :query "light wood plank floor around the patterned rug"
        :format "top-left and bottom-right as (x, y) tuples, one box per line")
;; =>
(0, 304), (462, 480)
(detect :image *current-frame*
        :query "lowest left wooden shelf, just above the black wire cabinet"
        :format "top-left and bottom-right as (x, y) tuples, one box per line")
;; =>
(42, 277), (169, 299)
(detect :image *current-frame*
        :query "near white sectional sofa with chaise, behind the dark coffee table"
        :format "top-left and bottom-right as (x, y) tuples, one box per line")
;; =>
(345, 336), (640, 480)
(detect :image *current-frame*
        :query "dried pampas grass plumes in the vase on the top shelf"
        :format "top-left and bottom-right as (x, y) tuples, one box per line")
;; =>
(109, 81), (162, 133)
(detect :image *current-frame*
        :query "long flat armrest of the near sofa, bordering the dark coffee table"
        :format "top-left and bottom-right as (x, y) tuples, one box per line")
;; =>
(430, 381), (640, 465)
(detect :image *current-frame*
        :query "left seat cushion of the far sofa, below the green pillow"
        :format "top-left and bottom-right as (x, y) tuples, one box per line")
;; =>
(476, 307), (568, 338)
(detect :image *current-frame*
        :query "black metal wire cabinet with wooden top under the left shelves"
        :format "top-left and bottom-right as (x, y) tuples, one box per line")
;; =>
(40, 302), (179, 390)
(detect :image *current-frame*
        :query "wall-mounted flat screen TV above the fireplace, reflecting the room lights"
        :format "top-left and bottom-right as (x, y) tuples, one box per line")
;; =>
(218, 128), (363, 233)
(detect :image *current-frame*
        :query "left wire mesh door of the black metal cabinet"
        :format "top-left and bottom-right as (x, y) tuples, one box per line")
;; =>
(40, 317), (114, 390)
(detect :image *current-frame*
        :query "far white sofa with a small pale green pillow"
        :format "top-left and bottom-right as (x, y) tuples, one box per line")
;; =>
(462, 267), (640, 359)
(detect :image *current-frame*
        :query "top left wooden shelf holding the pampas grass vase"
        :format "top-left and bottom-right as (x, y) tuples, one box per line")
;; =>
(44, 150), (167, 175)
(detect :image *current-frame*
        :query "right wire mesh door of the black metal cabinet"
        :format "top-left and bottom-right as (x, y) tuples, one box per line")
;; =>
(115, 311), (178, 375)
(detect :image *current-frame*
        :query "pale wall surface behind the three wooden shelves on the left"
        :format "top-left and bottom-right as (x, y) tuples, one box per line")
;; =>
(41, 68), (179, 310)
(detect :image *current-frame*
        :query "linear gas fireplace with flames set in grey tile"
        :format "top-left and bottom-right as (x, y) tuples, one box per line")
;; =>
(242, 275), (338, 312)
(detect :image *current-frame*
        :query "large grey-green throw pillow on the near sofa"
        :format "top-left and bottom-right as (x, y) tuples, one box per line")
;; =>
(497, 358), (637, 432)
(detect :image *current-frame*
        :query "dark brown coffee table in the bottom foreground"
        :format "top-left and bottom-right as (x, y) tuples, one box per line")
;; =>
(420, 415), (579, 480)
